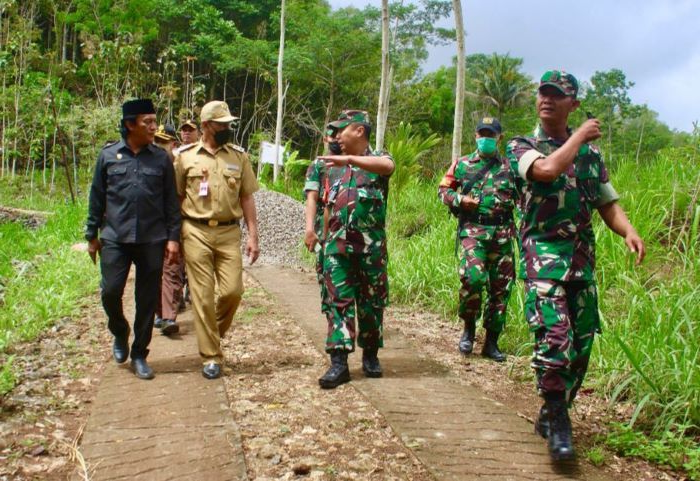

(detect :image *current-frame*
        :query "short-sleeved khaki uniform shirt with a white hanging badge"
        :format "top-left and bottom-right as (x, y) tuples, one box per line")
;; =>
(175, 141), (259, 222)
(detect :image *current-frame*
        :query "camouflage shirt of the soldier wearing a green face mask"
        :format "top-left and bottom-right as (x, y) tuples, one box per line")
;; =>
(438, 151), (517, 240)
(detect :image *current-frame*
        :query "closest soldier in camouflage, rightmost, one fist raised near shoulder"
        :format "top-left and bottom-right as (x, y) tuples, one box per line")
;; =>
(507, 70), (645, 460)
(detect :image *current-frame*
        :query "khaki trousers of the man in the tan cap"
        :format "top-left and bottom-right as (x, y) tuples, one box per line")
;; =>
(182, 219), (243, 364)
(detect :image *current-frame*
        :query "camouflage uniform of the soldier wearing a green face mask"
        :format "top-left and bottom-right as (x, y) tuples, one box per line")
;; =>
(438, 151), (517, 333)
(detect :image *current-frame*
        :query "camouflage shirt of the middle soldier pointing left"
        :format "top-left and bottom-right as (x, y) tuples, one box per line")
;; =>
(325, 150), (391, 254)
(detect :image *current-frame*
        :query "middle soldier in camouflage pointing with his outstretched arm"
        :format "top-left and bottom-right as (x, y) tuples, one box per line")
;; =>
(319, 110), (394, 389)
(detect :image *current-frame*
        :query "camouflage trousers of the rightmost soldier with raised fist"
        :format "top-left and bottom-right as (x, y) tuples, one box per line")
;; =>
(525, 279), (600, 403)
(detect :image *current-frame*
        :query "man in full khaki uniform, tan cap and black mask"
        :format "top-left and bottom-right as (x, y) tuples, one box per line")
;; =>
(175, 101), (260, 379)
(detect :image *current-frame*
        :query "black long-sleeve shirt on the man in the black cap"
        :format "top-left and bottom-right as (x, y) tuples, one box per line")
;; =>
(85, 140), (181, 244)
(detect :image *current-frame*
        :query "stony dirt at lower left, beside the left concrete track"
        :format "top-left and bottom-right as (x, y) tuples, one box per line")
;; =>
(0, 296), (111, 481)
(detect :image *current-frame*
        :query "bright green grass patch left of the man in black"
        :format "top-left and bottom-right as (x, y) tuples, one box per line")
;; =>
(0, 172), (99, 394)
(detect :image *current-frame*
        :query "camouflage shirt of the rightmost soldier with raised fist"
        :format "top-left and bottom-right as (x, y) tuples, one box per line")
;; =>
(506, 127), (618, 281)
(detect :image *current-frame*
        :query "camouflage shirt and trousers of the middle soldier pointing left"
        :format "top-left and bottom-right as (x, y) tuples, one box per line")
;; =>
(323, 150), (390, 352)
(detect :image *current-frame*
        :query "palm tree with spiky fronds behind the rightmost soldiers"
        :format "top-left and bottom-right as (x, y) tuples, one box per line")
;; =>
(467, 53), (533, 119)
